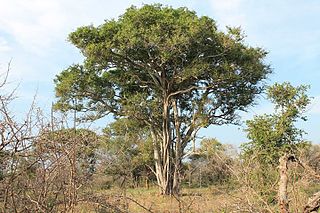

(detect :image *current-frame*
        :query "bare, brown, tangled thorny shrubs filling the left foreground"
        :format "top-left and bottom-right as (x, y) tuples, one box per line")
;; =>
(0, 64), (121, 212)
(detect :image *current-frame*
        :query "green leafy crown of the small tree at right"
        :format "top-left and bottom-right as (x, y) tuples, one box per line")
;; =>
(242, 82), (310, 165)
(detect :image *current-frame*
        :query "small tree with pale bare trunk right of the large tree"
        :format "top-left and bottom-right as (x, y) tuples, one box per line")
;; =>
(242, 82), (310, 212)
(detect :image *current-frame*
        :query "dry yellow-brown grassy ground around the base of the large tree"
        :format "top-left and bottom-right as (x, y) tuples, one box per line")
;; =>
(75, 182), (320, 213)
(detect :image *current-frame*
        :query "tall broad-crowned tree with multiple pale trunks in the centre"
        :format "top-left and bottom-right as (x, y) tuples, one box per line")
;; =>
(55, 4), (271, 194)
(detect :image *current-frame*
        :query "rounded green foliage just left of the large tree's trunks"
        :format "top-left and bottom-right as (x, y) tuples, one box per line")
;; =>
(102, 118), (153, 184)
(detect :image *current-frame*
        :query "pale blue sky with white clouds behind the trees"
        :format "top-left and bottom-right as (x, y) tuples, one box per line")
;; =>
(0, 0), (320, 145)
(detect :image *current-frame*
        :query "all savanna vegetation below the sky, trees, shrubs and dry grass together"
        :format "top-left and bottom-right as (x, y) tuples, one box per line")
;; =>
(0, 5), (320, 213)
